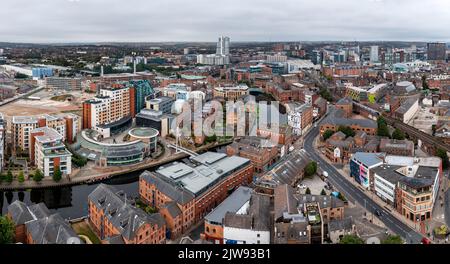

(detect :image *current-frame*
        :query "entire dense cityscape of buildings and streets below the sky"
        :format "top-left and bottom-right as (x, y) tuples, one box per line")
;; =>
(0, 36), (450, 244)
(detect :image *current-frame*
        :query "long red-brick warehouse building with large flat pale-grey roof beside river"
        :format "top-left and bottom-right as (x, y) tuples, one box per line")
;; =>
(139, 152), (254, 237)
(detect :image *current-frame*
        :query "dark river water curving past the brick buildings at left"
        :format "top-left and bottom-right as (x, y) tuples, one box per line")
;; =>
(0, 144), (229, 219)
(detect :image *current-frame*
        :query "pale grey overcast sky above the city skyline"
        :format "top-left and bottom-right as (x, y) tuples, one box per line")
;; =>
(0, 0), (450, 43)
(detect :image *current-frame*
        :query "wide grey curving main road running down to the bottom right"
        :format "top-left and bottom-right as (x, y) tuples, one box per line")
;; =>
(304, 121), (423, 244)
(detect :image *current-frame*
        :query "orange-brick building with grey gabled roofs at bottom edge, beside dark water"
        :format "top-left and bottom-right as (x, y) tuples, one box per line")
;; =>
(88, 184), (166, 244)
